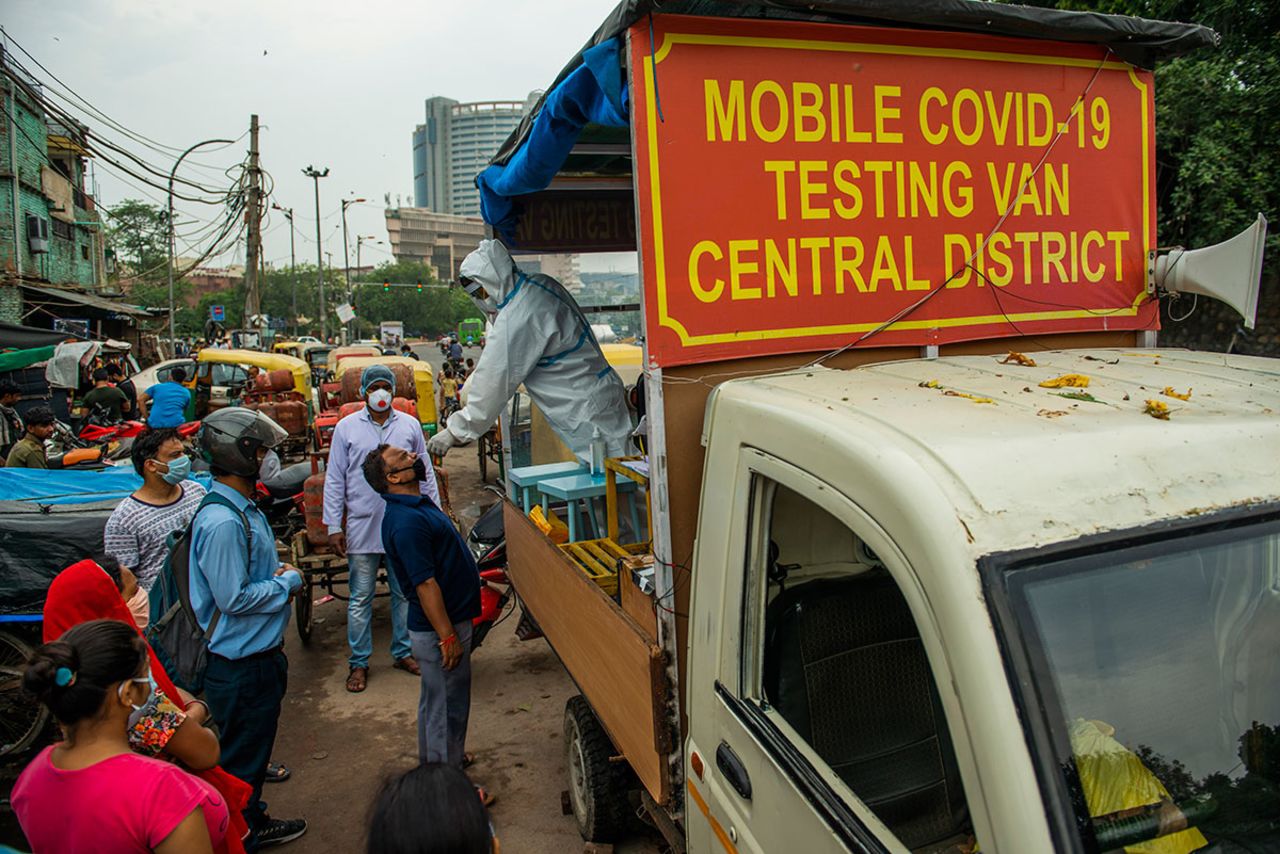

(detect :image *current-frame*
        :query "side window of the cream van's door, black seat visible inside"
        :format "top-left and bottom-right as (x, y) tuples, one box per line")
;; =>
(742, 475), (973, 851)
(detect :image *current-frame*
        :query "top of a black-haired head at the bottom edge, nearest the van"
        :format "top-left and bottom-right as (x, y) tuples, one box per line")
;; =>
(366, 762), (493, 854)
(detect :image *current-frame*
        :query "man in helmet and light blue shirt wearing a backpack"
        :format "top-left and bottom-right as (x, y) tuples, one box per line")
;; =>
(189, 407), (307, 851)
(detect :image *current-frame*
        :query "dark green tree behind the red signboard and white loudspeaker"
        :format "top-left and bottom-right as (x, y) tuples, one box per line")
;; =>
(998, 0), (1280, 355)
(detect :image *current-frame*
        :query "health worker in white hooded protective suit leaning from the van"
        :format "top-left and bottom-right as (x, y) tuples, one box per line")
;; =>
(426, 239), (631, 463)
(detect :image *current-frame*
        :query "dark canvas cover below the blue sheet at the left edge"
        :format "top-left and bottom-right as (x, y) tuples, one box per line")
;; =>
(0, 501), (119, 615)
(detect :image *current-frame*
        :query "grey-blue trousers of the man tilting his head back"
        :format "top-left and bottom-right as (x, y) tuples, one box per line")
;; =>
(410, 620), (471, 768)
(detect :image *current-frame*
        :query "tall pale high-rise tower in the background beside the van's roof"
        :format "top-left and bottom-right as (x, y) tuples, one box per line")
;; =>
(413, 92), (539, 216)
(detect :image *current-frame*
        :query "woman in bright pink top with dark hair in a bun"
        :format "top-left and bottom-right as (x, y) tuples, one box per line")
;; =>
(10, 620), (229, 854)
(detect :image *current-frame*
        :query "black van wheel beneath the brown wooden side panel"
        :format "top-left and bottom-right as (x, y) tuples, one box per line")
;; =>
(564, 694), (631, 842)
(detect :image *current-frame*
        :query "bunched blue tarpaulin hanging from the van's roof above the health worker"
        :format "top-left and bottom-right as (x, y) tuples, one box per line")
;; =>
(476, 38), (630, 237)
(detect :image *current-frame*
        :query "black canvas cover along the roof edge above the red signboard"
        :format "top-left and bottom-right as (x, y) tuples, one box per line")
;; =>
(492, 0), (1220, 164)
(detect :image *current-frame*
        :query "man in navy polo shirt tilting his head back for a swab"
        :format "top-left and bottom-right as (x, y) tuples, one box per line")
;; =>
(364, 444), (480, 768)
